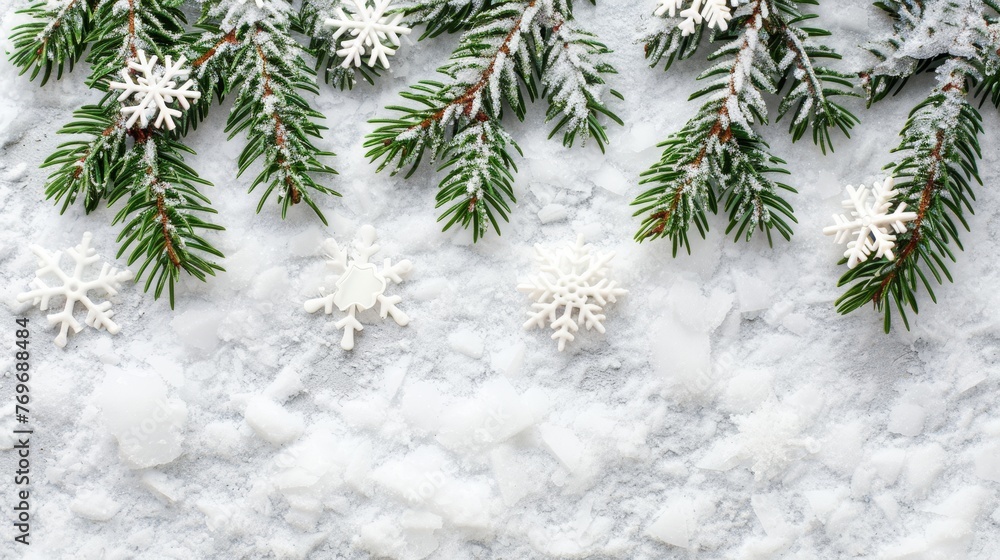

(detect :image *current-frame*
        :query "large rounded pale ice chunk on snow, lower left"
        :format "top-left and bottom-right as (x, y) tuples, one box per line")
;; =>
(95, 366), (187, 469)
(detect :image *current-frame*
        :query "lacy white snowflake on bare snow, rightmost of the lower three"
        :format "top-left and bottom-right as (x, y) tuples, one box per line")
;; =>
(517, 235), (628, 352)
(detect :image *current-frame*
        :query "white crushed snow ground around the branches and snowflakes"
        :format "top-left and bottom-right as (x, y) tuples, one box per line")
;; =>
(0, 0), (1000, 560)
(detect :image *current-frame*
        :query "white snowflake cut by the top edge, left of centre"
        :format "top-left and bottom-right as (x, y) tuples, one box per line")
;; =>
(323, 0), (410, 68)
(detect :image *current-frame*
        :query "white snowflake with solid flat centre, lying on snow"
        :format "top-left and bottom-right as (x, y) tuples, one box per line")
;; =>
(305, 226), (413, 350)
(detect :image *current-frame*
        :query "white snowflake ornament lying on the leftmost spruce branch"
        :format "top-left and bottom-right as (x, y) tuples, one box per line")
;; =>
(109, 49), (201, 130)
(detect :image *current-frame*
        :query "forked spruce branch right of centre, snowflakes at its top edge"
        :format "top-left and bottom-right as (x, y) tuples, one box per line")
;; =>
(633, 0), (858, 255)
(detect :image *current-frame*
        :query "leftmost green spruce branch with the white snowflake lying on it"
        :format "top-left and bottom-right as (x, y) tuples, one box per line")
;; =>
(12, 0), (222, 303)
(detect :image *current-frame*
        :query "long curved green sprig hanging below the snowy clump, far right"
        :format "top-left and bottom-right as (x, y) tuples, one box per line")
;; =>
(837, 65), (983, 332)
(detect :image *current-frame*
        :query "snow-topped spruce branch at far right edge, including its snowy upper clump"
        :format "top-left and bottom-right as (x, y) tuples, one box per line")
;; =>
(837, 0), (1000, 332)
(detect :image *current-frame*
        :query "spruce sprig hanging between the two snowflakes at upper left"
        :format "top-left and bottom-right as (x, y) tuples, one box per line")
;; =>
(192, 0), (340, 224)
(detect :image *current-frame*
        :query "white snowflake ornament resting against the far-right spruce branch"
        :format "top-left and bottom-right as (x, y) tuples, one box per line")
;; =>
(823, 177), (917, 268)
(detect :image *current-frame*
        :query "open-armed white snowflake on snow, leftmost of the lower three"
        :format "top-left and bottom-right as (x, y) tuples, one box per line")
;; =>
(17, 232), (132, 348)
